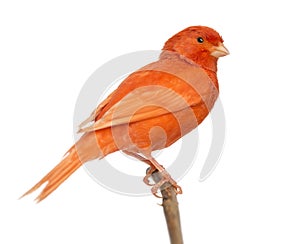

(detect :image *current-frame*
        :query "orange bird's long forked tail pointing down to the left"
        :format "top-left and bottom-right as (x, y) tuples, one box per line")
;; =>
(21, 146), (82, 202)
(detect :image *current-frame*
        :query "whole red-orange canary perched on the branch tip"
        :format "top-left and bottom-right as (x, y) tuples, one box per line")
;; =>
(21, 26), (229, 202)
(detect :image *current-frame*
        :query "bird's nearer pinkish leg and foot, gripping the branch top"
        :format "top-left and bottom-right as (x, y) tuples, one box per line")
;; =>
(149, 157), (182, 196)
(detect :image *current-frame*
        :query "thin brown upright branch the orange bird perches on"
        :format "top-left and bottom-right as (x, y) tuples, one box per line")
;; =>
(152, 171), (183, 244)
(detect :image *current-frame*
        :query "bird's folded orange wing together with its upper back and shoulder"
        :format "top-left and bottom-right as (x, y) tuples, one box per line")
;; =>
(79, 55), (218, 132)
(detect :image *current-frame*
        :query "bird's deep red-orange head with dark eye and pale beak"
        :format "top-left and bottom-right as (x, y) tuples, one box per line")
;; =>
(163, 26), (229, 69)
